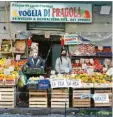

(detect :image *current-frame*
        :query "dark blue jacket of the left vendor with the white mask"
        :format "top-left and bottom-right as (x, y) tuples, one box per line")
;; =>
(26, 56), (45, 68)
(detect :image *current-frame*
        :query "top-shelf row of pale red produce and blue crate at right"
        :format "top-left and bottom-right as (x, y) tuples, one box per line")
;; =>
(69, 44), (112, 57)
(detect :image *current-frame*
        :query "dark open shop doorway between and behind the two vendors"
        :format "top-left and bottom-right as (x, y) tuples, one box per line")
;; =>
(32, 35), (60, 71)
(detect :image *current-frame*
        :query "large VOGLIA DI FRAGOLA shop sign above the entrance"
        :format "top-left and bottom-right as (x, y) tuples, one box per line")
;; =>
(10, 2), (92, 23)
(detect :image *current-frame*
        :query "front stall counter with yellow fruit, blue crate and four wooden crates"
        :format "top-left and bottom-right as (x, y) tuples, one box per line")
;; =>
(27, 73), (112, 108)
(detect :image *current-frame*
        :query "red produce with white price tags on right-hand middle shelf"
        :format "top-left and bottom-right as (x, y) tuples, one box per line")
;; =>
(72, 58), (111, 74)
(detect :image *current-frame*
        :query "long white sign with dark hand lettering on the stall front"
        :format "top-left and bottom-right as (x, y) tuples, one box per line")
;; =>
(51, 79), (81, 88)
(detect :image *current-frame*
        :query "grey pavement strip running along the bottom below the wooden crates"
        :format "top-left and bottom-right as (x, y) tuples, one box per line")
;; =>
(0, 108), (112, 115)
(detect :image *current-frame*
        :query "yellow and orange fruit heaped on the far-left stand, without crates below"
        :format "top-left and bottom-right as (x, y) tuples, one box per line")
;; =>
(0, 58), (26, 84)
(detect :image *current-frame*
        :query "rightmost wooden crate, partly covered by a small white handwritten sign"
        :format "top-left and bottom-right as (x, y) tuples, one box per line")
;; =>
(94, 88), (112, 107)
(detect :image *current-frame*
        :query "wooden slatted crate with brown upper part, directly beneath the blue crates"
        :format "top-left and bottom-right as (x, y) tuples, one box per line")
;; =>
(29, 90), (48, 108)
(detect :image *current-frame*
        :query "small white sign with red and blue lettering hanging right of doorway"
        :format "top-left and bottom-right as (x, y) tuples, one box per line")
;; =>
(64, 34), (81, 45)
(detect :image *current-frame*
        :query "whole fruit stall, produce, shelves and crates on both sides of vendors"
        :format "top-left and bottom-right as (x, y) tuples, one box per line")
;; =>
(0, 36), (112, 108)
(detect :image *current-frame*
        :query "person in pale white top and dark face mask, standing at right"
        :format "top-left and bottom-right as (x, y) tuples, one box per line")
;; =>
(55, 49), (72, 73)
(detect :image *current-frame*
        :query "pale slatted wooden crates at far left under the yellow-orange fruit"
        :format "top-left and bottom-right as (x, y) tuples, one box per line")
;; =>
(0, 87), (16, 108)
